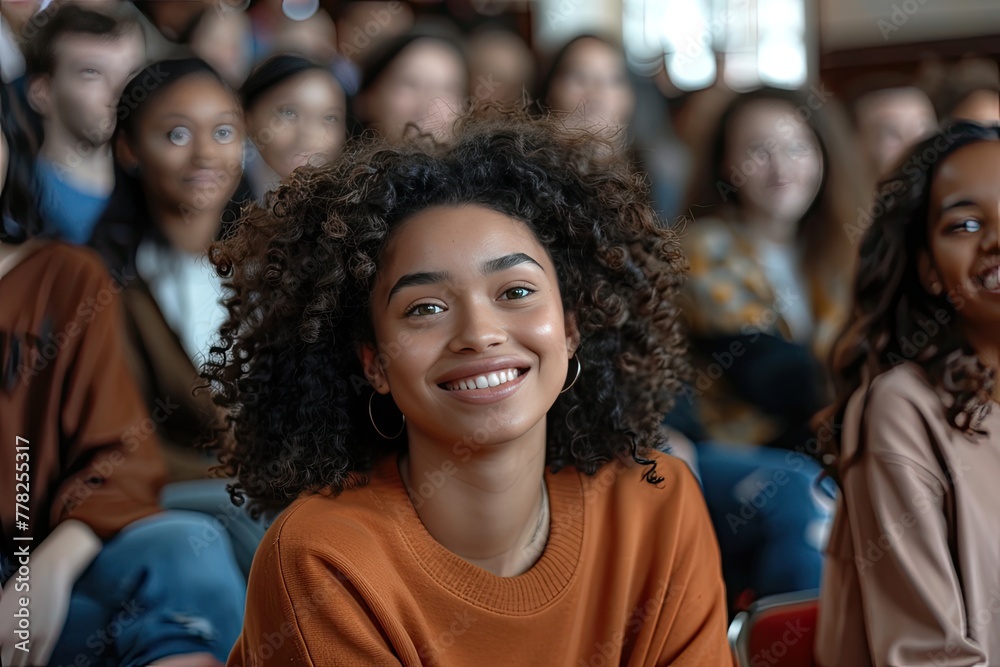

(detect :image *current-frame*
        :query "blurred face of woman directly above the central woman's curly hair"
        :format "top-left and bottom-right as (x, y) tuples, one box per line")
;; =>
(359, 39), (467, 141)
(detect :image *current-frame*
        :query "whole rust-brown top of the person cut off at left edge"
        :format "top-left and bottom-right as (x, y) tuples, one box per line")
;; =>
(0, 242), (165, 553)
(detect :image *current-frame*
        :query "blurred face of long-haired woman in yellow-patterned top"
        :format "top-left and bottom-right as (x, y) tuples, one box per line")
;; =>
(723, 100), (823, 239)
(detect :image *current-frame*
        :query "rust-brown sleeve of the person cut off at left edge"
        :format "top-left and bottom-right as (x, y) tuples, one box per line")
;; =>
(50, 253), (166, 539)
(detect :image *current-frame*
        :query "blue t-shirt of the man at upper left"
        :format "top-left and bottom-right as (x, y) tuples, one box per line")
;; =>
(35, 158), (111, 244)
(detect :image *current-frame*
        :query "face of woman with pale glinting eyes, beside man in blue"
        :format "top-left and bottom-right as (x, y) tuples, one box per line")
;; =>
(131, 75), (243, 213)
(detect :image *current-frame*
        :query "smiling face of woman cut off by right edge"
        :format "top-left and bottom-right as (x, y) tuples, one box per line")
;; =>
(924, 141), (1000, 341)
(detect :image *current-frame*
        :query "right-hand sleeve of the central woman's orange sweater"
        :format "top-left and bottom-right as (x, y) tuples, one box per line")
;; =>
(650, 471), (733, 667)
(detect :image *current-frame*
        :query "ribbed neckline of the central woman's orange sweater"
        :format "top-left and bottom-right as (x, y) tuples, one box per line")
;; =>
(369, 454), (586, 615)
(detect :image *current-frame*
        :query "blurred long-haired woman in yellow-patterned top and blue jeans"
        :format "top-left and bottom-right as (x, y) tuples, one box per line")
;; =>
(668, 89), (863, 612)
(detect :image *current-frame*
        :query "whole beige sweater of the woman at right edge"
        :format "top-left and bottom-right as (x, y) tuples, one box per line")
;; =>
(816, 363), (1000, 667)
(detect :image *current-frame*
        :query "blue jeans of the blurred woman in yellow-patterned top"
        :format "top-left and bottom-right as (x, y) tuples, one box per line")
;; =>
(697, 442), (834, 608)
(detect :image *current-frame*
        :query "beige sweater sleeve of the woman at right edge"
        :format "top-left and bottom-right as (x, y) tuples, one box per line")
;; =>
(844, 387), (986, 667)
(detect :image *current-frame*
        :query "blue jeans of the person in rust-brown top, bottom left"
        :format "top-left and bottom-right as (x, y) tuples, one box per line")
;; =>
(49, 510), (246, 667)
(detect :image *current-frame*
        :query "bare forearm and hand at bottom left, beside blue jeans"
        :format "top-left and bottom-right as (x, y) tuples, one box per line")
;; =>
(0, 519), (103, 667)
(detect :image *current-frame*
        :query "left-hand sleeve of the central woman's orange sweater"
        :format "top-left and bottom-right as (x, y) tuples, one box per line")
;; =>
(226, 505), (400, 667)
